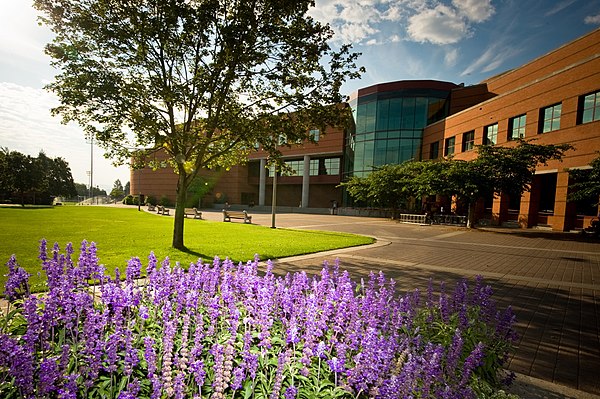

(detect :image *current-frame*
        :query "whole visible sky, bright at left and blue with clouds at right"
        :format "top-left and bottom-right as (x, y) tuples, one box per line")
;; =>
(0, 0), (600, 191)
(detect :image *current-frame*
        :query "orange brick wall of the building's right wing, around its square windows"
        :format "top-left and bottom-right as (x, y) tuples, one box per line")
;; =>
(422, 30), (600, 231)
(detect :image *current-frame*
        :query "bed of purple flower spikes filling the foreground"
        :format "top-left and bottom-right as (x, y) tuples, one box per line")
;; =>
(0, 241), (516, 398)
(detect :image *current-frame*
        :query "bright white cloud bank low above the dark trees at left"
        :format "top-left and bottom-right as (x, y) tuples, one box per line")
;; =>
(0, 82), (129, 190)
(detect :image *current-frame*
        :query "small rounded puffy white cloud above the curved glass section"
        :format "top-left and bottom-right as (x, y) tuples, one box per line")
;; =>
(408, 4), (468, 44)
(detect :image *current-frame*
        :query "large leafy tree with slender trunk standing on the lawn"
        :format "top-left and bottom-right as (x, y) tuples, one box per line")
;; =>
(34, 0), (361, 249)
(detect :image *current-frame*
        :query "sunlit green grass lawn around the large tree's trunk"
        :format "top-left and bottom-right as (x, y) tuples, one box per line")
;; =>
(0, 206), (373, 293)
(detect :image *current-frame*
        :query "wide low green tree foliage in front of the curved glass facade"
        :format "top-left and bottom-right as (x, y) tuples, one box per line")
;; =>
(341, 140), (572, 226)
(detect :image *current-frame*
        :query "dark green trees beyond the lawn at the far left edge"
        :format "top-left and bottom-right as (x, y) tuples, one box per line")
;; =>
(0, 148), (77, 206)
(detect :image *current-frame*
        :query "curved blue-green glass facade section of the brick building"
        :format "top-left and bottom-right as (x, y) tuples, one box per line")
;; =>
(344, 81), (458, 177)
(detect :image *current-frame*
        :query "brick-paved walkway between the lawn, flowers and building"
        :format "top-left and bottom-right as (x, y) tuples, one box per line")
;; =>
(198, 211), (600, 398)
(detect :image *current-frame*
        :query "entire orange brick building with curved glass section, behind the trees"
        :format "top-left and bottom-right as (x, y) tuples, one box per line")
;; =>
(131, 29), (600, 230)
